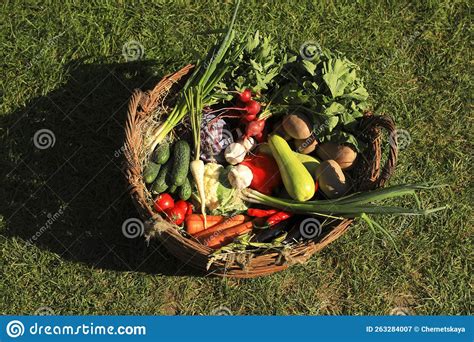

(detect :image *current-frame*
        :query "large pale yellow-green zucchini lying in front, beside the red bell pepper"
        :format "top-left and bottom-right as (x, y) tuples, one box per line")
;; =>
(268, 134), (316, 201)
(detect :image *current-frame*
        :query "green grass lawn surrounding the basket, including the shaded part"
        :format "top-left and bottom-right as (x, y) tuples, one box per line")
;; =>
(0, 0), (474, 314)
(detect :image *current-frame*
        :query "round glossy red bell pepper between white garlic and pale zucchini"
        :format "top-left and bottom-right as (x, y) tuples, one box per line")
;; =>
(240, 153), (281, 195)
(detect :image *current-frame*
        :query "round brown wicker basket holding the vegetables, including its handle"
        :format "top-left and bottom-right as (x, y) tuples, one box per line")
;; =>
(124, 65), (397, 278)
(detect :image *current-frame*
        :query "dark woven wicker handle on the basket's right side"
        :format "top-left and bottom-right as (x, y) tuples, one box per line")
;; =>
(361, 113), (398, 188)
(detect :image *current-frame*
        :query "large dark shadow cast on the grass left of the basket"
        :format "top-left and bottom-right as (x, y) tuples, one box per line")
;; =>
(0, 61), (204, 275)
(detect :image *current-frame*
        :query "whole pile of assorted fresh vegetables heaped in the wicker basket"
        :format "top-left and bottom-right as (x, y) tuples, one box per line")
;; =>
(143, 2), (443, 253)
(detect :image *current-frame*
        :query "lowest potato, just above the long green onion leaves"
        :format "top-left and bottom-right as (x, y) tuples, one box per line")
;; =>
(316, 160), (349, 199)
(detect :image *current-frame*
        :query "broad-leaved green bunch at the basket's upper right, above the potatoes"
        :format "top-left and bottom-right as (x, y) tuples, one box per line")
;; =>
(271, 50), (369, 151)
